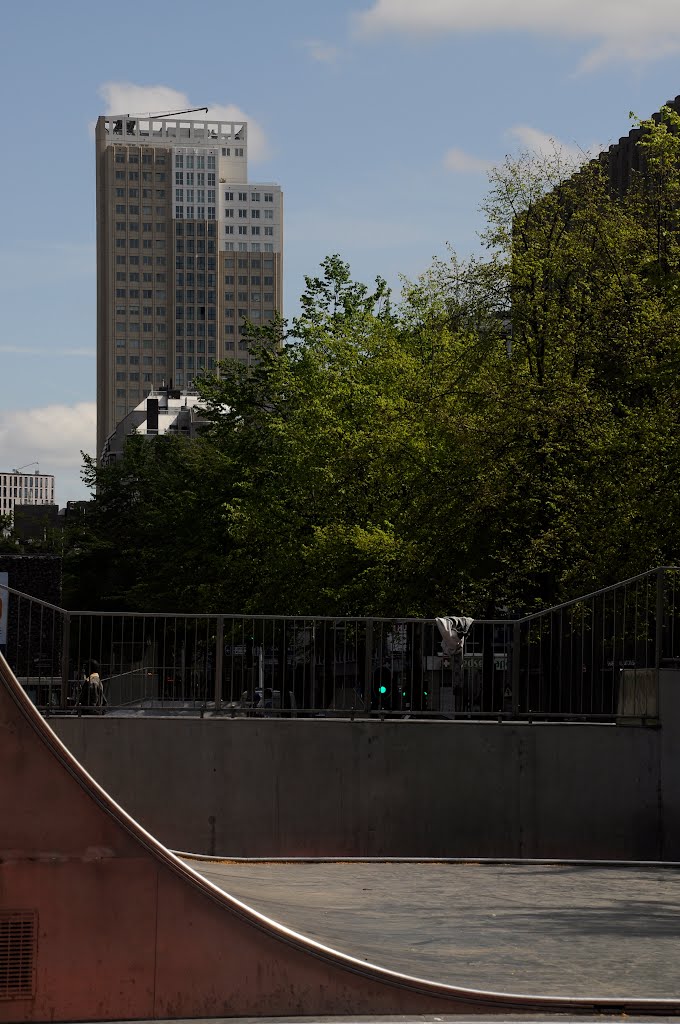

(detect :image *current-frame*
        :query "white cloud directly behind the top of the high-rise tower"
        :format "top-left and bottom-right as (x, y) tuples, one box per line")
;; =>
(97, 82), (269, 164)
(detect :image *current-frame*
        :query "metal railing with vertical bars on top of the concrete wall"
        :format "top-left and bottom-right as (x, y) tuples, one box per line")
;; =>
(4, 566), (680, 722)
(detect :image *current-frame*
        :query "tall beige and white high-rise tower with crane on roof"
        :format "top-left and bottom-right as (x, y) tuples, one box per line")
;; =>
(95, 115), (283, 453)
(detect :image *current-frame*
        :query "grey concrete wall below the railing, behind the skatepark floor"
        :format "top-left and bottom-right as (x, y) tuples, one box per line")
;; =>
(50, 696), (680, 859)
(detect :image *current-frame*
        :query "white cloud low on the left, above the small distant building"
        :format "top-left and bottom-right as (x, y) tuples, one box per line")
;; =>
(0, 401), (96, 485)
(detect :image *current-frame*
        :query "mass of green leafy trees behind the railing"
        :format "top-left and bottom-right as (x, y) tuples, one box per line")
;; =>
(71, 111), (680, 615)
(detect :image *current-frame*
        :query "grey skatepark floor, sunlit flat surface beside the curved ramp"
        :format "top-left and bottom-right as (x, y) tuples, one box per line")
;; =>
(180, 858), (680, 1000)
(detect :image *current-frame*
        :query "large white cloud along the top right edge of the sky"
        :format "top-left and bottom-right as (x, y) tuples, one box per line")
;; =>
(355, 0), (680, 71)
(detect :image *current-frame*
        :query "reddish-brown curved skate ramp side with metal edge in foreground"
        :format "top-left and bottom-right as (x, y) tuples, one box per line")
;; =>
(0, 655), (680, 1022)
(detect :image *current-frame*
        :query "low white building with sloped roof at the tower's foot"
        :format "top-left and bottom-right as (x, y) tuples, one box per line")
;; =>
(99, 387), (208, 464)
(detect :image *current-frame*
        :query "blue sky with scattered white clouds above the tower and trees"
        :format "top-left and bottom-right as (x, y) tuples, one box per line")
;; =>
(0, 0), (680, 504)
